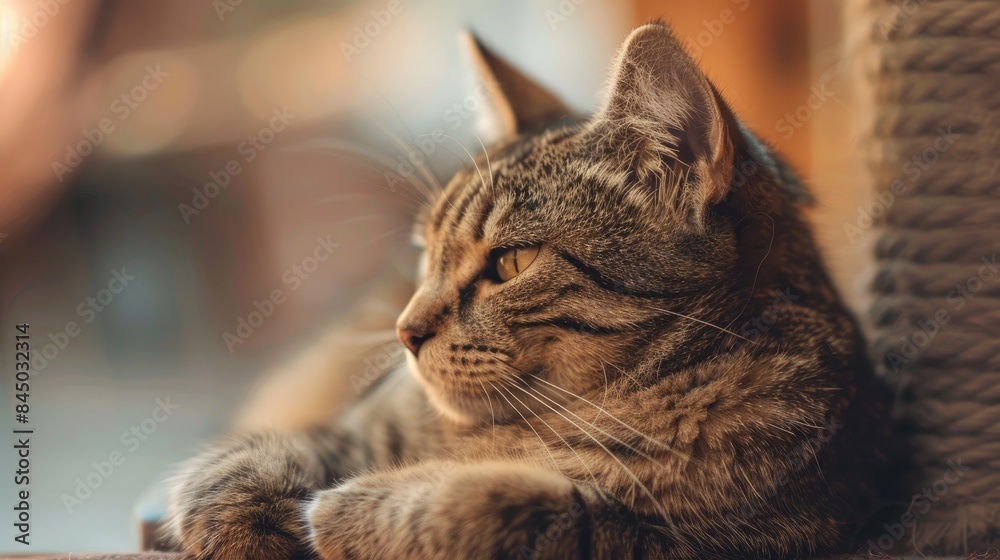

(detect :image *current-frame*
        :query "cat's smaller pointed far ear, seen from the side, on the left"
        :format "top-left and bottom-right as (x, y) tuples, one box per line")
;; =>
(460, 31), (570, 143)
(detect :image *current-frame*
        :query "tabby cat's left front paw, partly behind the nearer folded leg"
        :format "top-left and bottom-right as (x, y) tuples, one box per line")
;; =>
(168, 435), (316, 560)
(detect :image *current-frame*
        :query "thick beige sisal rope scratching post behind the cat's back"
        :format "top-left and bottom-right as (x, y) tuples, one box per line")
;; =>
(860, 0), (1000, 554)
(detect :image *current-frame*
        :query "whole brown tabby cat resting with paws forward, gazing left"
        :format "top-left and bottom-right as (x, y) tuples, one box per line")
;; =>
(167, 21), (888, 560)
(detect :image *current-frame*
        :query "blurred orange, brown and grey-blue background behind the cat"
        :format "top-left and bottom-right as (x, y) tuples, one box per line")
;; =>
(0, 0), (866, 554)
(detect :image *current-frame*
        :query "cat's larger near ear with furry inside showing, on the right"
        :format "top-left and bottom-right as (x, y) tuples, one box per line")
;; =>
(596, 23), (735, 223)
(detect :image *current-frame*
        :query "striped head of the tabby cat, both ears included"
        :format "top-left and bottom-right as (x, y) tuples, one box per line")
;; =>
(397, 23), (800, 423)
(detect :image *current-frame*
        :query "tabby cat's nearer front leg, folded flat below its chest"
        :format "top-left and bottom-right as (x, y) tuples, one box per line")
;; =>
(306, 462), (656, 560)
